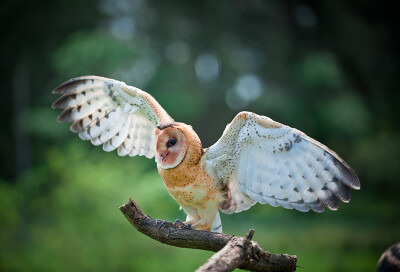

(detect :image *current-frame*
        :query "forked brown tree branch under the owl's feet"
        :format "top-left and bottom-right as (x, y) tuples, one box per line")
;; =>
(119, 199), (297, 271)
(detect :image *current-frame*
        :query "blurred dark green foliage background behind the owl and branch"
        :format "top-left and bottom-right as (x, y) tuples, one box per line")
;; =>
(0, 0), (400, 271)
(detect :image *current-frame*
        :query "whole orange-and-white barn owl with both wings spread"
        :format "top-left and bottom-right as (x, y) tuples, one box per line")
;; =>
(52, 76), (360, 232)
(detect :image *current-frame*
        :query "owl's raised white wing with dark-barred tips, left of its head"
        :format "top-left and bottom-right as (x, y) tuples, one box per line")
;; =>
(52, 76), (173, 158)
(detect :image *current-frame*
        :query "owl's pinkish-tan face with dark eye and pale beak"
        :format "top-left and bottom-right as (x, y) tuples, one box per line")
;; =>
(155, 122), (189, 169)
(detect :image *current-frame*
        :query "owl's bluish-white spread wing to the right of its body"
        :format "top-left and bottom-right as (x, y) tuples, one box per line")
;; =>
(204, 112), (360, 213)
